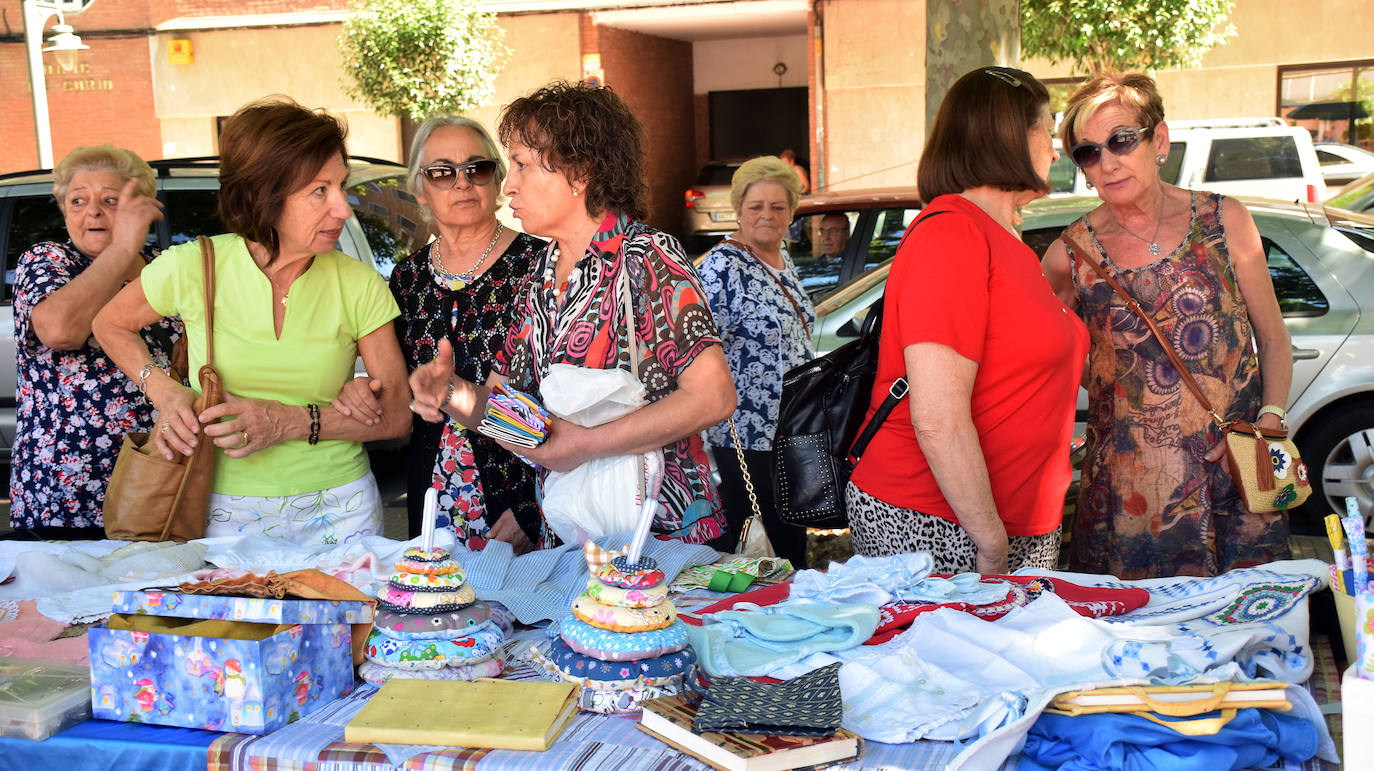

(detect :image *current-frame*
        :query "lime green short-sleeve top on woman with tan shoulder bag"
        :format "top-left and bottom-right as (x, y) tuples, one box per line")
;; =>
(140, 234), (400, 496)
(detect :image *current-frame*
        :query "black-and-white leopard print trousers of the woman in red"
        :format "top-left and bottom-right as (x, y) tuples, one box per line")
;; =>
(845, 482), (1059, 573)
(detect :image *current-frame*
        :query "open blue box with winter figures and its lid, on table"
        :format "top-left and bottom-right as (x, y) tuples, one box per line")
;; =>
(89, 591), (372, 734)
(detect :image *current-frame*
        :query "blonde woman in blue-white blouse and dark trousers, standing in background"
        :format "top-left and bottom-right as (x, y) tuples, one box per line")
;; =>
(697, 155), (816, 568)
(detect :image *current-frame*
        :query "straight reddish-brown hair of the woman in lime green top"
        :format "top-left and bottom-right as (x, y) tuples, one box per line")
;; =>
(220, 96), (348, 261)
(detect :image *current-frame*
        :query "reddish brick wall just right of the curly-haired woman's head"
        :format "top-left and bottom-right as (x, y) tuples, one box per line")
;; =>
(584, 26), (697, 234)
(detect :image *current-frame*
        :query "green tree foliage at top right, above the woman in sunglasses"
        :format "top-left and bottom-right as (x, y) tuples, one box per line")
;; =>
(1021, 0), (1235, 74)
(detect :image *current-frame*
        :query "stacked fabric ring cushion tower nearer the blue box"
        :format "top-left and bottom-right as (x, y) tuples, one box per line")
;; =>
(359, 547), (506, 684)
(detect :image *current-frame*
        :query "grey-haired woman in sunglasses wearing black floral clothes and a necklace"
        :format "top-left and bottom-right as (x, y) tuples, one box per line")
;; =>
(392, 115), (545, 552)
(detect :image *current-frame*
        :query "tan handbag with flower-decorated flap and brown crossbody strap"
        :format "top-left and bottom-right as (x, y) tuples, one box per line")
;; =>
(1061, 235), (1312, 514)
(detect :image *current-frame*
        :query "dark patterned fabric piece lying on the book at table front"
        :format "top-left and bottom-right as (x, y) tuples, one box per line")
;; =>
(692, 654), (845, 737)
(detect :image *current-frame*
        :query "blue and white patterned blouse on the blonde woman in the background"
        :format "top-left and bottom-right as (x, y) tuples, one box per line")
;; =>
(697, 241), (816, 451)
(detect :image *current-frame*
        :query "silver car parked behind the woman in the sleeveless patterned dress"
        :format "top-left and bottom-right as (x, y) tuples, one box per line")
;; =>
(813, 191), (1374, 533)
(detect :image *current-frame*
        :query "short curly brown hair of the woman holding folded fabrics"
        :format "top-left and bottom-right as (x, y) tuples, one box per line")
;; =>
(496, 80), (647, 220)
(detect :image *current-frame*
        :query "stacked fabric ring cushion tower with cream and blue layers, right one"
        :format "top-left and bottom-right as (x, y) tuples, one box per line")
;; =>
(530, 541), (697, 713)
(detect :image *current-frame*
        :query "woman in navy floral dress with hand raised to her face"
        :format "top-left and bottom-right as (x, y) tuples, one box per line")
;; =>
(10, 144), (181, 539)
